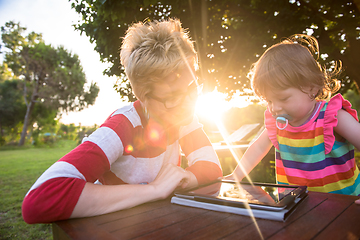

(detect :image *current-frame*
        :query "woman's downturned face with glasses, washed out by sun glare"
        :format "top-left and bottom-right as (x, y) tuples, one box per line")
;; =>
(144, 68), (198, 127)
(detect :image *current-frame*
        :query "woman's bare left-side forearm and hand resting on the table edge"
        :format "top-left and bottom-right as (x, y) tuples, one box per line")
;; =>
(70, 164), (193, 218)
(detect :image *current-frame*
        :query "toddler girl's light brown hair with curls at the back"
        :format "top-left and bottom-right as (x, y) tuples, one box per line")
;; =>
(248, 34), (341, 99)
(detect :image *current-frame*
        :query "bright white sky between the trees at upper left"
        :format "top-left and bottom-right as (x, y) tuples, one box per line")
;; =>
(0, 0), (127, 126)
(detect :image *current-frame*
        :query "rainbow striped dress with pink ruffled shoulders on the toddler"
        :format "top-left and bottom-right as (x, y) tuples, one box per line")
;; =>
(265, 94), (360, 195)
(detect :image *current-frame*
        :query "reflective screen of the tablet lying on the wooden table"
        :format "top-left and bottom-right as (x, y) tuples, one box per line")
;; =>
(190, 182), (295, 205)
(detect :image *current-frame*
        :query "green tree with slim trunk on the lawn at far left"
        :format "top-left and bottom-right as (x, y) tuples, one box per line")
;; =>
(1, 22), (99, 145)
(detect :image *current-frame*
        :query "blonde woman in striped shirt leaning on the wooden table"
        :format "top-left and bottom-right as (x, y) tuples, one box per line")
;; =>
(22, 19), (222, 223)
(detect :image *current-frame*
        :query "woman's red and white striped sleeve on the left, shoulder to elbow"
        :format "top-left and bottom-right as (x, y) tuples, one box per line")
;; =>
(22, 104), (137, 223)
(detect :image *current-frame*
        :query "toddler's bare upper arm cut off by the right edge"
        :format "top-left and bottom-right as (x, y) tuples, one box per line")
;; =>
(334, 109), (360, 150)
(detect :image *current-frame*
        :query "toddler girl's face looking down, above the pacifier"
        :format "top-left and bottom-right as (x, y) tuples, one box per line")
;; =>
(265, 88), (316, 127)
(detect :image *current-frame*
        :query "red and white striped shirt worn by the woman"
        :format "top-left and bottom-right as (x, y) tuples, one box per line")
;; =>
(22, 101), (222, 223)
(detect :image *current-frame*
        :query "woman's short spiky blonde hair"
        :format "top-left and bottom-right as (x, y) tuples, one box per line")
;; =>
(120, 19), (197, 101)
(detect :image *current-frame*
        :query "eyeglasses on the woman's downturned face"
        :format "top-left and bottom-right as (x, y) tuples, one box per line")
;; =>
(147, 80), (204, 109)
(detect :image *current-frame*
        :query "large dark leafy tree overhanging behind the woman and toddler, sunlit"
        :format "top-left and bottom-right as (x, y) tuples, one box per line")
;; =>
(69, 0), (360, 100)
